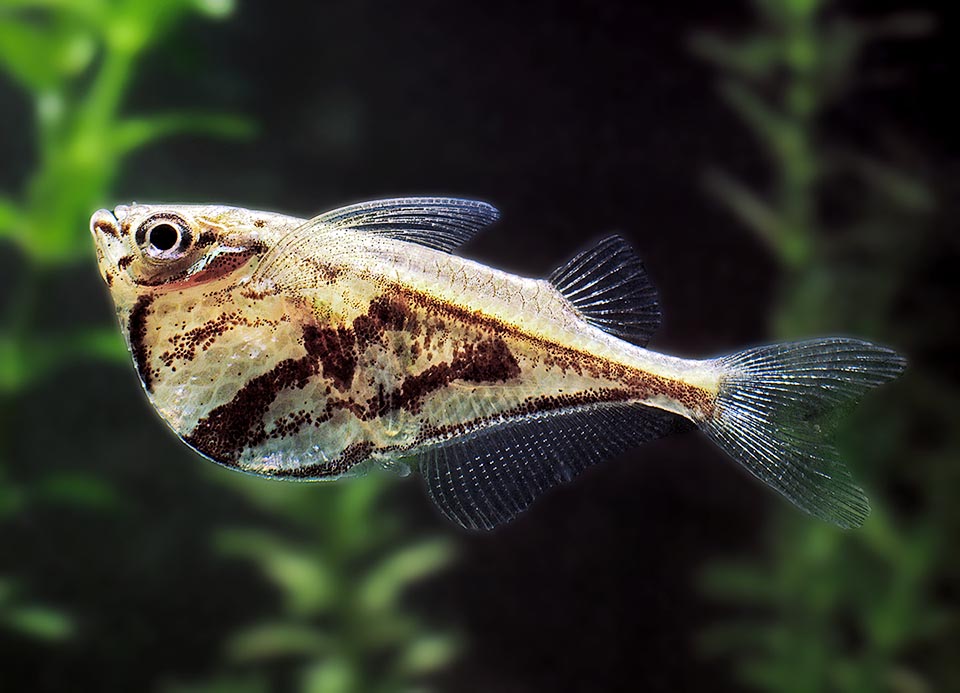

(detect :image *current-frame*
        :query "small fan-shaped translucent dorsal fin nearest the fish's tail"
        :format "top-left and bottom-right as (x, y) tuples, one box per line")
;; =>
(549, 236), (660, 346)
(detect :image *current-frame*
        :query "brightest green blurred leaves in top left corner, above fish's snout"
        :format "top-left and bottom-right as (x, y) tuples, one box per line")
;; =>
(0, 0), (244, 264)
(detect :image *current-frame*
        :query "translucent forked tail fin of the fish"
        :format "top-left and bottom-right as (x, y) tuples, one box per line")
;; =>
(701, 337), (906, 527)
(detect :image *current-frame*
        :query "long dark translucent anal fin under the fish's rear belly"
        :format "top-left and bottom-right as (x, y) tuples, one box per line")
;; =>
(420, 404), (689, 529)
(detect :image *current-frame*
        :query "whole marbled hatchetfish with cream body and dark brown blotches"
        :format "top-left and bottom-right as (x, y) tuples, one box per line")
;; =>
(90, 197), (906, 530)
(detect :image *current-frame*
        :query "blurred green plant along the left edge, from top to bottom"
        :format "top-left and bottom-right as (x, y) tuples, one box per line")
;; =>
(0, 0), (249, 640)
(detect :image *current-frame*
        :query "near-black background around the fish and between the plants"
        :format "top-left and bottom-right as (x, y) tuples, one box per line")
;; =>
(0, 0), (960, 693)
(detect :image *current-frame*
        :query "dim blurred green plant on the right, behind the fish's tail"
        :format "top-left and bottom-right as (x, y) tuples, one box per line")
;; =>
(693, 5), (955, 693)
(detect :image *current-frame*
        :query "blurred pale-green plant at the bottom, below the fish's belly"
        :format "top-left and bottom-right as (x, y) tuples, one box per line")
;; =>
(165, 470), (458, 693)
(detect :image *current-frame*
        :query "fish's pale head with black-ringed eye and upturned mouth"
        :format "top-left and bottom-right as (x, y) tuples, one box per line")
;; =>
(90, 204), (299, 307)
